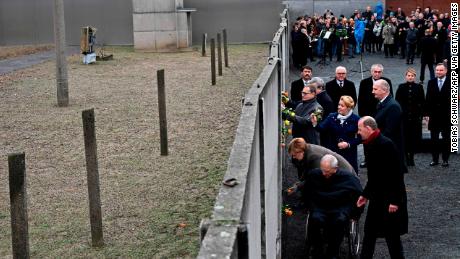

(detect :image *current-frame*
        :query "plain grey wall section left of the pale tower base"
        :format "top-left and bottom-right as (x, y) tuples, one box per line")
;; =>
(0, 0), (133, 45)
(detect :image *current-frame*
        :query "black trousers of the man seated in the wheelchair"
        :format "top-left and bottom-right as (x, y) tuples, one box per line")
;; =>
(308, 210), (349, 258)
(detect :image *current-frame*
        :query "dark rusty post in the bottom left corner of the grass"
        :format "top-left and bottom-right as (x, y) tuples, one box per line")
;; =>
(8, 153), (30, 259)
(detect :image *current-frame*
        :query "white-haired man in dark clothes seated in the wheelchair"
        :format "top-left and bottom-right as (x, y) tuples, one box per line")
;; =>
(303, 155), (362, 258)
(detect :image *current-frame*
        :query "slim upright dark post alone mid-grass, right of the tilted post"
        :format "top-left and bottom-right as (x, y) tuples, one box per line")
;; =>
(157, 69), (168, 156)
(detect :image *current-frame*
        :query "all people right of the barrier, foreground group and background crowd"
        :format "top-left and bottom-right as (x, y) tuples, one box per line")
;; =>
(283, 7), (451, 258)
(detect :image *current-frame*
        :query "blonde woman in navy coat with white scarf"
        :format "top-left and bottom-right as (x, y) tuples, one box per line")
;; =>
(312, 95), (361, 173)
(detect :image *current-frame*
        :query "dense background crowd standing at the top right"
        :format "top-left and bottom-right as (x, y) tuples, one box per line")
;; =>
(291, 6), (451, 82)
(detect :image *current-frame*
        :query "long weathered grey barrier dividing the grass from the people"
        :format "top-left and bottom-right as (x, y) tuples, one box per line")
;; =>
(198, 9), (289, 258)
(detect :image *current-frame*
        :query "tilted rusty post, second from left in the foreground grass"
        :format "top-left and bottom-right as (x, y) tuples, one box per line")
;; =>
(82, 109), (104, 247)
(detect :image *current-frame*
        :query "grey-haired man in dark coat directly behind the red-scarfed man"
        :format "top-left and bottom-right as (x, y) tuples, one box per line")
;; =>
(372, 79), (407, 173)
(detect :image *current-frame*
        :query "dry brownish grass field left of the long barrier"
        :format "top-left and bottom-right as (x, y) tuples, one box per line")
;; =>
(0, 45), (267, 258)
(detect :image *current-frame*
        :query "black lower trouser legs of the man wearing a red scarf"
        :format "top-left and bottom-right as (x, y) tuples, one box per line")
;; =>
(360, 232), (404, 259)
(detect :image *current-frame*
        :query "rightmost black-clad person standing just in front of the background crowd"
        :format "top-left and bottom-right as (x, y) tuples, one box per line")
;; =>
(420, 29), (436, 84)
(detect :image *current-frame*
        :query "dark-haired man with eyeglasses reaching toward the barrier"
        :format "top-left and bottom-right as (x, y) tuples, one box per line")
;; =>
(286, 84), (323, 145)
